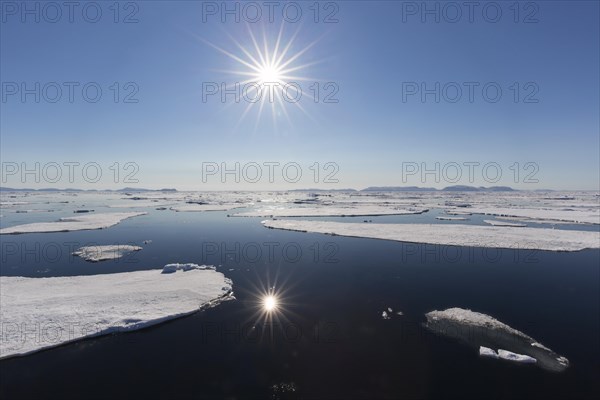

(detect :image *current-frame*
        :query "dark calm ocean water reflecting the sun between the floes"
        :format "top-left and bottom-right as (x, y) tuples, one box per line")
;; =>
(0, 210), (600, 399)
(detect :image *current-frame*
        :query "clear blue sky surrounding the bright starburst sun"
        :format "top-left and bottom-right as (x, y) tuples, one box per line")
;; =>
(0, 1), (600, 190)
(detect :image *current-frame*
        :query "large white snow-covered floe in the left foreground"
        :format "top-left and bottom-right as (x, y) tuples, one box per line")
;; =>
(0, 264), (231, 358)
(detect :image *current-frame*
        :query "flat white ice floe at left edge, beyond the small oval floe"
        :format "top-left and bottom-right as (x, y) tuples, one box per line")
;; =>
(0, 212), (147, 235)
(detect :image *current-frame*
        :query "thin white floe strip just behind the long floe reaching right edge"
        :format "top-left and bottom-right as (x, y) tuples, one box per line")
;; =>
(232, 205), (428, 217)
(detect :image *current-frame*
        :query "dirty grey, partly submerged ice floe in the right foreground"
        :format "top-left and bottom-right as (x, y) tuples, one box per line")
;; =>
(425, 308), (569, 372)
